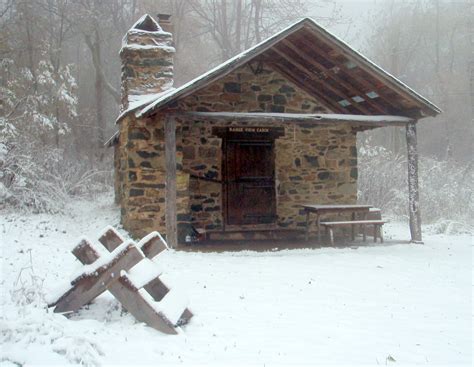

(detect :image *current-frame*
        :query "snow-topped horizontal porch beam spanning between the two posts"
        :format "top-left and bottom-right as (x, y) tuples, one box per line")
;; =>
(176, 112), (416, 127)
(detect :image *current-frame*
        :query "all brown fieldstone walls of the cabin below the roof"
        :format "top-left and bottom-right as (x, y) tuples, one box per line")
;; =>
(118, 61), (357, 241)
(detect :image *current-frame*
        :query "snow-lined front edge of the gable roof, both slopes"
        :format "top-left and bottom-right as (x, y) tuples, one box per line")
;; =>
(117, 18), (441, 121)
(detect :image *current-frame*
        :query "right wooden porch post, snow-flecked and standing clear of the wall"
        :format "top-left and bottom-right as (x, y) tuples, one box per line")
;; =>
(406, 122), (422, 243)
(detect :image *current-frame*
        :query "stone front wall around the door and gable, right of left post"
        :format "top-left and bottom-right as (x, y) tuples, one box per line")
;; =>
(179, 65), (357, 236)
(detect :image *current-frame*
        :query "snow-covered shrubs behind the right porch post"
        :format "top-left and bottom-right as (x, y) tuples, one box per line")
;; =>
(359, 147), (474, 226)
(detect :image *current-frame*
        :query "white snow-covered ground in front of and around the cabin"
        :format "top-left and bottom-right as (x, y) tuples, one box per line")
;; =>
(0, 197), (473, 366)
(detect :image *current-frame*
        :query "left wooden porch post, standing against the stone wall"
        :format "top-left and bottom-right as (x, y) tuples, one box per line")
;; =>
(165, 116), (178, 248)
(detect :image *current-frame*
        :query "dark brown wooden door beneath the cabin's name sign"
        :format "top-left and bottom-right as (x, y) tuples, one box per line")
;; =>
(224, 140), (276, 225)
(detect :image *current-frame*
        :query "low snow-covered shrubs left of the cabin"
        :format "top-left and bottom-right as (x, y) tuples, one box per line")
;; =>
(0, 143), (112, 212)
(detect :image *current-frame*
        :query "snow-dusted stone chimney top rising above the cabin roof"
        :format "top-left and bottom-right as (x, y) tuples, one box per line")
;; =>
(120, 14), (175, 112)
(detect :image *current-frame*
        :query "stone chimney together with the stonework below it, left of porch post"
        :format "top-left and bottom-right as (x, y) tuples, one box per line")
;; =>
(114, 15), (175, 237)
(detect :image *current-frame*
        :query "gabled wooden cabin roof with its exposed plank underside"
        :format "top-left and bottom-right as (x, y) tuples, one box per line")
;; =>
(122, 18), (441, 123)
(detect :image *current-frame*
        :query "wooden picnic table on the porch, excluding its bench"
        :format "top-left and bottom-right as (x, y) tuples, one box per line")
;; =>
(302, 204), (372, 243)
